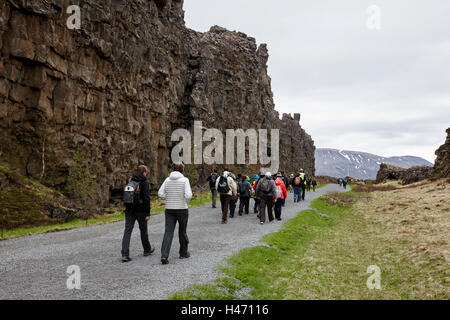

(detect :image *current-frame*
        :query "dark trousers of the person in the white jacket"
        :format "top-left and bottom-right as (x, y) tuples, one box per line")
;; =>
(161, 209), (189, 258)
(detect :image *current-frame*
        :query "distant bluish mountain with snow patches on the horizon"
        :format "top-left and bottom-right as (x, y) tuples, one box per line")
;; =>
(316, 148), (433, 179)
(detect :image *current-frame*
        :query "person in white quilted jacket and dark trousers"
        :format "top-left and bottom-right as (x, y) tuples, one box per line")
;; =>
(158, 163), (192, 264)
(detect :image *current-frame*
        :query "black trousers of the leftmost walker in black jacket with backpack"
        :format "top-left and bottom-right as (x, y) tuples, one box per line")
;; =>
(122, 209), (151, 257)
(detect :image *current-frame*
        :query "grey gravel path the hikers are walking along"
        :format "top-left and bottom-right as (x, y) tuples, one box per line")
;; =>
(0, 185), (343, 299)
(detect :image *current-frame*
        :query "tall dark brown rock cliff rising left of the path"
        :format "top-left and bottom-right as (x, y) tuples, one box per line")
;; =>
(0, 0), (315, 206)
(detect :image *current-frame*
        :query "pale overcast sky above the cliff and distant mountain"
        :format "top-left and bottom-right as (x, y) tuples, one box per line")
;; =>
(184, 0), (450, 162)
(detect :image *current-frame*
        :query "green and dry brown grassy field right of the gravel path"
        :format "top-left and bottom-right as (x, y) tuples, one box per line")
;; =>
(171, 181), (450, 300)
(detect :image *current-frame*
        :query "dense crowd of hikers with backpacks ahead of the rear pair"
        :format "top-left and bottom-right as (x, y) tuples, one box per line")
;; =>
(207, 168), (317, 224)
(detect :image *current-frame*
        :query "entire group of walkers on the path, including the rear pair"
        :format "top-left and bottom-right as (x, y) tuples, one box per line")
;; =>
(122, 163), (317, 264)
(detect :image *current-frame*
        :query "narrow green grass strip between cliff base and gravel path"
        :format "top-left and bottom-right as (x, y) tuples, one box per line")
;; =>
(0, 192), (211, 241)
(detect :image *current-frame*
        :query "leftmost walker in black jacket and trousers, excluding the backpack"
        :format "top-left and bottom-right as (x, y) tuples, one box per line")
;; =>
(122, 165), (155, 262)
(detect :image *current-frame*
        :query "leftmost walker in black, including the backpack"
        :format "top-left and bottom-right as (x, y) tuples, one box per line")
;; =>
(122, 165), (155, 262)
